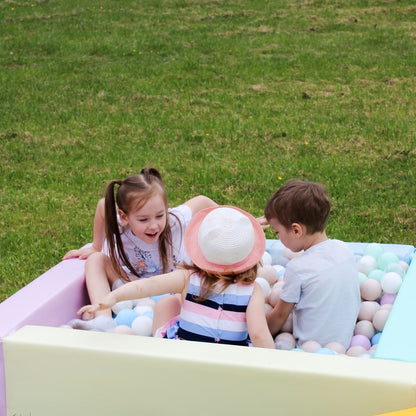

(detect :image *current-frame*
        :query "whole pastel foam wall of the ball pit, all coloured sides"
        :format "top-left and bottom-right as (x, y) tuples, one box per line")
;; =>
(0, 240), (416, 416)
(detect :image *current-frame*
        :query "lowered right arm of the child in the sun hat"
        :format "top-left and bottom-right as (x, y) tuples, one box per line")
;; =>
(246, 283), (275, 349)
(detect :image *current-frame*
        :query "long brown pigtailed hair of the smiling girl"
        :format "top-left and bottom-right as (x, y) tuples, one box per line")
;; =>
(105, 168), (179, 280)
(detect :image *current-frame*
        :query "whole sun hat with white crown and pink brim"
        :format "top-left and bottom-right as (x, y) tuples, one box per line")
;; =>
(184, 205), (266, 274)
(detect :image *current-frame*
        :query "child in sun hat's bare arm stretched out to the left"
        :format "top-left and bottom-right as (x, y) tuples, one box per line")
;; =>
(77, 269), (189, 315)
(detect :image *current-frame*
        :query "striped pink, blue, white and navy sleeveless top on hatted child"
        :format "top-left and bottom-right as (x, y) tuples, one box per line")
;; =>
(177, 273), (254, 345)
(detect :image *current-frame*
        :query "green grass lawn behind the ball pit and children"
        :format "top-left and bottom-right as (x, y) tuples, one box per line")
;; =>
(0, 0), (416, 301)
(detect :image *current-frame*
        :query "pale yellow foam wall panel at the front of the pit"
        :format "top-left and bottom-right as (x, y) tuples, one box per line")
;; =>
(3, 326), (416, 416)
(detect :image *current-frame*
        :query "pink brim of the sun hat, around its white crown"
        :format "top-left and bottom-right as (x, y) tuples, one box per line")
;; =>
(184, 205), (266, 274)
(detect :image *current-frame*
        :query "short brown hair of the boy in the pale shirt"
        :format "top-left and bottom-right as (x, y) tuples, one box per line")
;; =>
(264, 179), (331, 234)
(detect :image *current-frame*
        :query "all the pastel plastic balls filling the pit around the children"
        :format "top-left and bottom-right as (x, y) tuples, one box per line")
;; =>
(69, 241), (408, 358)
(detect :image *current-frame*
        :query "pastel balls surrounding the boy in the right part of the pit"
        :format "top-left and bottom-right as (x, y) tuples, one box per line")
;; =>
(256, 241), (408, 358)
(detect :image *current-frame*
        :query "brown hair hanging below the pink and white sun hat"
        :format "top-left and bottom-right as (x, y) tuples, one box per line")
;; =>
(181, 264), (259, 302)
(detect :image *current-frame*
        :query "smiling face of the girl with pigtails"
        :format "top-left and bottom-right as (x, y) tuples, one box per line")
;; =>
(119, 193), (167, 244)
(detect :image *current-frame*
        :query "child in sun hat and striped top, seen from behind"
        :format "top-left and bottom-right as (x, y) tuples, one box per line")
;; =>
(79, 206), (275, 348)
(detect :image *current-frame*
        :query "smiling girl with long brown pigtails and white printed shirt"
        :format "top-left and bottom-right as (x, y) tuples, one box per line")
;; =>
(64, 168), (217, 328)
